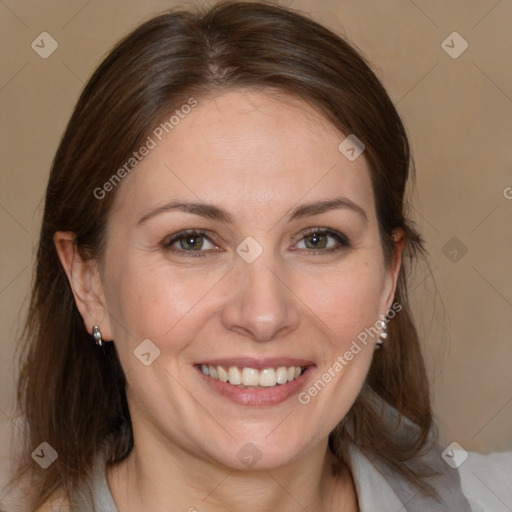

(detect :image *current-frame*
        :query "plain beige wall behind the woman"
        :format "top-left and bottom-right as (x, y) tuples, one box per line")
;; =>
(0, 0), (512, 452)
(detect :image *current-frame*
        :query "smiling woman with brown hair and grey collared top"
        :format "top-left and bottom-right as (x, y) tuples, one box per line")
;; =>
(12, 2), (471, 512)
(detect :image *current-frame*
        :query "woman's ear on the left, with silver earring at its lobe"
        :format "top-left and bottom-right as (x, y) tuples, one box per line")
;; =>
(53, 231), (112, 341)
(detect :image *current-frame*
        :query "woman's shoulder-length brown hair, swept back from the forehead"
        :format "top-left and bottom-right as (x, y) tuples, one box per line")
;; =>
(14, 2), (433, 509)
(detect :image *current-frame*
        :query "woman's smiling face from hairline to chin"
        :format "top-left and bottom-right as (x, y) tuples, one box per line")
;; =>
(95, 90), (401, 469)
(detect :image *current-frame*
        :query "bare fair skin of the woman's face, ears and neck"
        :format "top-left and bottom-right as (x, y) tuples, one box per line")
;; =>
(55, 90), (403, 512)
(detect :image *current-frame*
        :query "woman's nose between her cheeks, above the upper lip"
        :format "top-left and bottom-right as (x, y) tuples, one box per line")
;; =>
(221, 252), (300, 341)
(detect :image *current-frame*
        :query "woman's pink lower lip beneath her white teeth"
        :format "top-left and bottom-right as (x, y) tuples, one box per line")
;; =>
(196, 366), (313, 406)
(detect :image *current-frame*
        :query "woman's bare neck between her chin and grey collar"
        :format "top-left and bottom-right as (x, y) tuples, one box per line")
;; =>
(107, 430), (358, 512)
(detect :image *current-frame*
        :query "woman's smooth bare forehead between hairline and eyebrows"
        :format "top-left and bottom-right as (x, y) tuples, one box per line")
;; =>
(110, 90), (373, 224)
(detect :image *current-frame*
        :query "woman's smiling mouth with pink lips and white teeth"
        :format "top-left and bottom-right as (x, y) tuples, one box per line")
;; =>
(194, 358), (315, 406)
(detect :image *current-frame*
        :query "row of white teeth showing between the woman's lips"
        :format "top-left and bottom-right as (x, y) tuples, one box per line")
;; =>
(201, 364), (302, 387)
